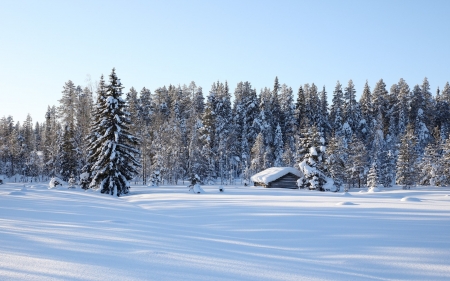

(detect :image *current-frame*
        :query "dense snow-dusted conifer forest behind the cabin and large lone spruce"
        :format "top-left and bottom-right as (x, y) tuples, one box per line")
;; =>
(0, 72), (450, 190)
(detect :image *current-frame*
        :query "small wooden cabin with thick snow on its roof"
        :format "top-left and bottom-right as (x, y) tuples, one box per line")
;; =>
(251, 167), (302, 189)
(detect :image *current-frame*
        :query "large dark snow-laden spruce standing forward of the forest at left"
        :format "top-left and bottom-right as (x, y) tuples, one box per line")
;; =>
(89, 68), (140, 196)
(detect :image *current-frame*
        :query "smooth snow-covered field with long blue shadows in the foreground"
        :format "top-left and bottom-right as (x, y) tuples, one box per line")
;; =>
(0, 180), (450, 280)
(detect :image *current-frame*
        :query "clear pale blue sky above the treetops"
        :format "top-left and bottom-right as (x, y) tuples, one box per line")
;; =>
(0, 0), (450, 122)
